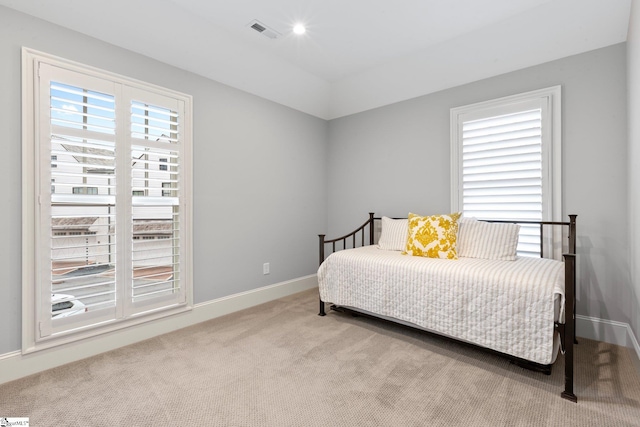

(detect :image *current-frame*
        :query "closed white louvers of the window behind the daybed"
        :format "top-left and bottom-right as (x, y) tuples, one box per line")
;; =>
(461, 109), (543, 256)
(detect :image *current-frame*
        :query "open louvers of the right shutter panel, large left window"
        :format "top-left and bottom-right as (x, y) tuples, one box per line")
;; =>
(131, 101), (181, 306)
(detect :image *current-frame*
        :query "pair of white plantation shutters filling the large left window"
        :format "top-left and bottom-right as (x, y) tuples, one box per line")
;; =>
(23, 49), (191, 347)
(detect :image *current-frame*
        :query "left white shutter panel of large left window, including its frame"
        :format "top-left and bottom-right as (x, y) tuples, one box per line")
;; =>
(38, 64), (117, 338)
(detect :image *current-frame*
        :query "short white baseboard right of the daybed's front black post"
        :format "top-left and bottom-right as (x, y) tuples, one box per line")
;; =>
(576, 315), (640, 359)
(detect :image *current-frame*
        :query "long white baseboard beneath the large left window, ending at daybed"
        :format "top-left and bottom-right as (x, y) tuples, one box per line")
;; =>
(0, 274), (318, 384)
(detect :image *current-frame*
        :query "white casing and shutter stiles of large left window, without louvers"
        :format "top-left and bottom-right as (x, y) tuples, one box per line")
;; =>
(22, 47), (193, 354)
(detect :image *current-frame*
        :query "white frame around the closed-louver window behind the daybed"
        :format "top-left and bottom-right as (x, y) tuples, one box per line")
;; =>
(450, 85), (563, 257)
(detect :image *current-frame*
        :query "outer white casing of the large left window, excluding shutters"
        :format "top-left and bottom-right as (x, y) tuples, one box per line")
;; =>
(22, 47), (193, 354)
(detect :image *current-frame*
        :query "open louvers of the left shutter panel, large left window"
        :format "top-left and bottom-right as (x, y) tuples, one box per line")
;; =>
(50, 82), (116, 318)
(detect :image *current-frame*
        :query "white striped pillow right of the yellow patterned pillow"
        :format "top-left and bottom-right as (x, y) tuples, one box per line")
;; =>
(457, 218), (520, 261)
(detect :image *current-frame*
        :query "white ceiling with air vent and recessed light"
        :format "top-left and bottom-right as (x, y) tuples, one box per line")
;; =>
(0, 0), (632, 119)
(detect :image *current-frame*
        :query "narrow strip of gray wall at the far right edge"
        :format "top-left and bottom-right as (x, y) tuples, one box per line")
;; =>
(627, 1), (640, 348)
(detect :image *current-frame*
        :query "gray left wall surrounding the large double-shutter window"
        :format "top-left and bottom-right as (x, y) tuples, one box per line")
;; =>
(0, 7), (328, 355)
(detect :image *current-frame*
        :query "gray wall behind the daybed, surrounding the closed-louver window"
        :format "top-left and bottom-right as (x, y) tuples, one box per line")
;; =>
(327, 44), (636, 323)
